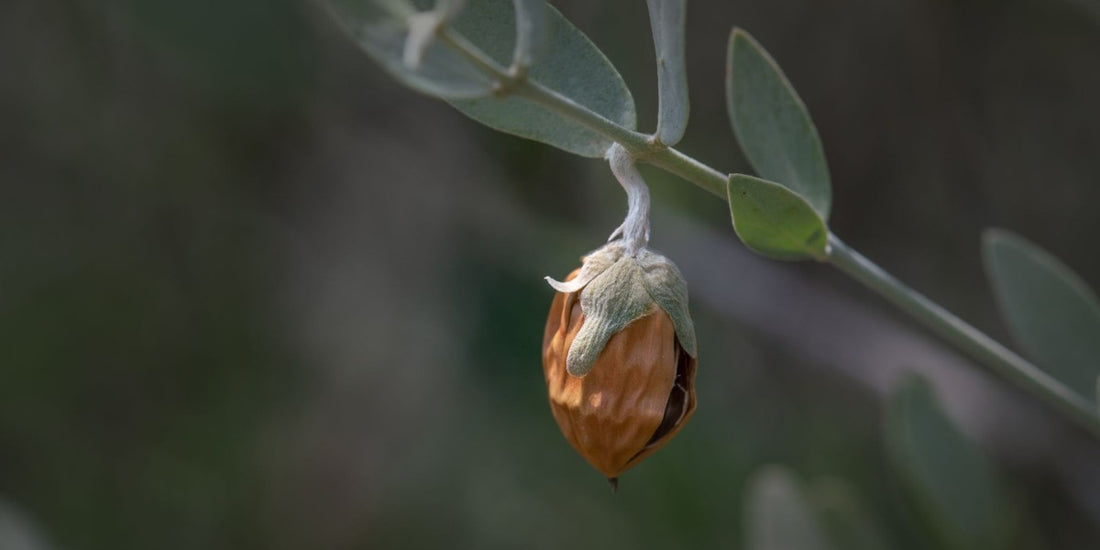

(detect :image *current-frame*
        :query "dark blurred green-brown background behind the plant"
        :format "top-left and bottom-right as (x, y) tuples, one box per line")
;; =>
(0, 0), (1100, 550)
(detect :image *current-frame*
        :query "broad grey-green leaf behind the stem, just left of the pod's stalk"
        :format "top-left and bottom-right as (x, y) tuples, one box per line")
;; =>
(451, 0), (636, 157)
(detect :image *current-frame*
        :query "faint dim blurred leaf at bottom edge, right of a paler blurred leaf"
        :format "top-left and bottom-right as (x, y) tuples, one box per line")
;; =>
(810, 477), (894, 550)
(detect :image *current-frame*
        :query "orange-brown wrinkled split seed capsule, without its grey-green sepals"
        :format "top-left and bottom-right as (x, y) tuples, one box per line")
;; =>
(542, 264), (697, 479)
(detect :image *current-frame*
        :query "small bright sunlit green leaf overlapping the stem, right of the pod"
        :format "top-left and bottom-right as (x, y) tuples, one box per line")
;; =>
(727, 174), (828, 260)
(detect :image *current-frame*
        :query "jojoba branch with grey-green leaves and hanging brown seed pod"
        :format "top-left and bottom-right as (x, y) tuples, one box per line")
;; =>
(322, 0), (1100, 484)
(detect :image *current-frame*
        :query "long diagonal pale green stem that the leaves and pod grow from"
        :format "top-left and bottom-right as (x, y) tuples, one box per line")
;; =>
(442, 24), (1100, 437)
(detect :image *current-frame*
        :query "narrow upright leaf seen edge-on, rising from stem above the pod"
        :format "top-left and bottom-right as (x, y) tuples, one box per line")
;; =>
(647, 0), (689, 146)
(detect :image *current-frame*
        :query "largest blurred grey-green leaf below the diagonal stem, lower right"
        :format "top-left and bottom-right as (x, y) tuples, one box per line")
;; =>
(886, 375), (1011, 549)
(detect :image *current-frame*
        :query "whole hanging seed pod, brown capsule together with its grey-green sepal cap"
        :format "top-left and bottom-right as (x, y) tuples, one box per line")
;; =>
(542, 243), (697, 480)
